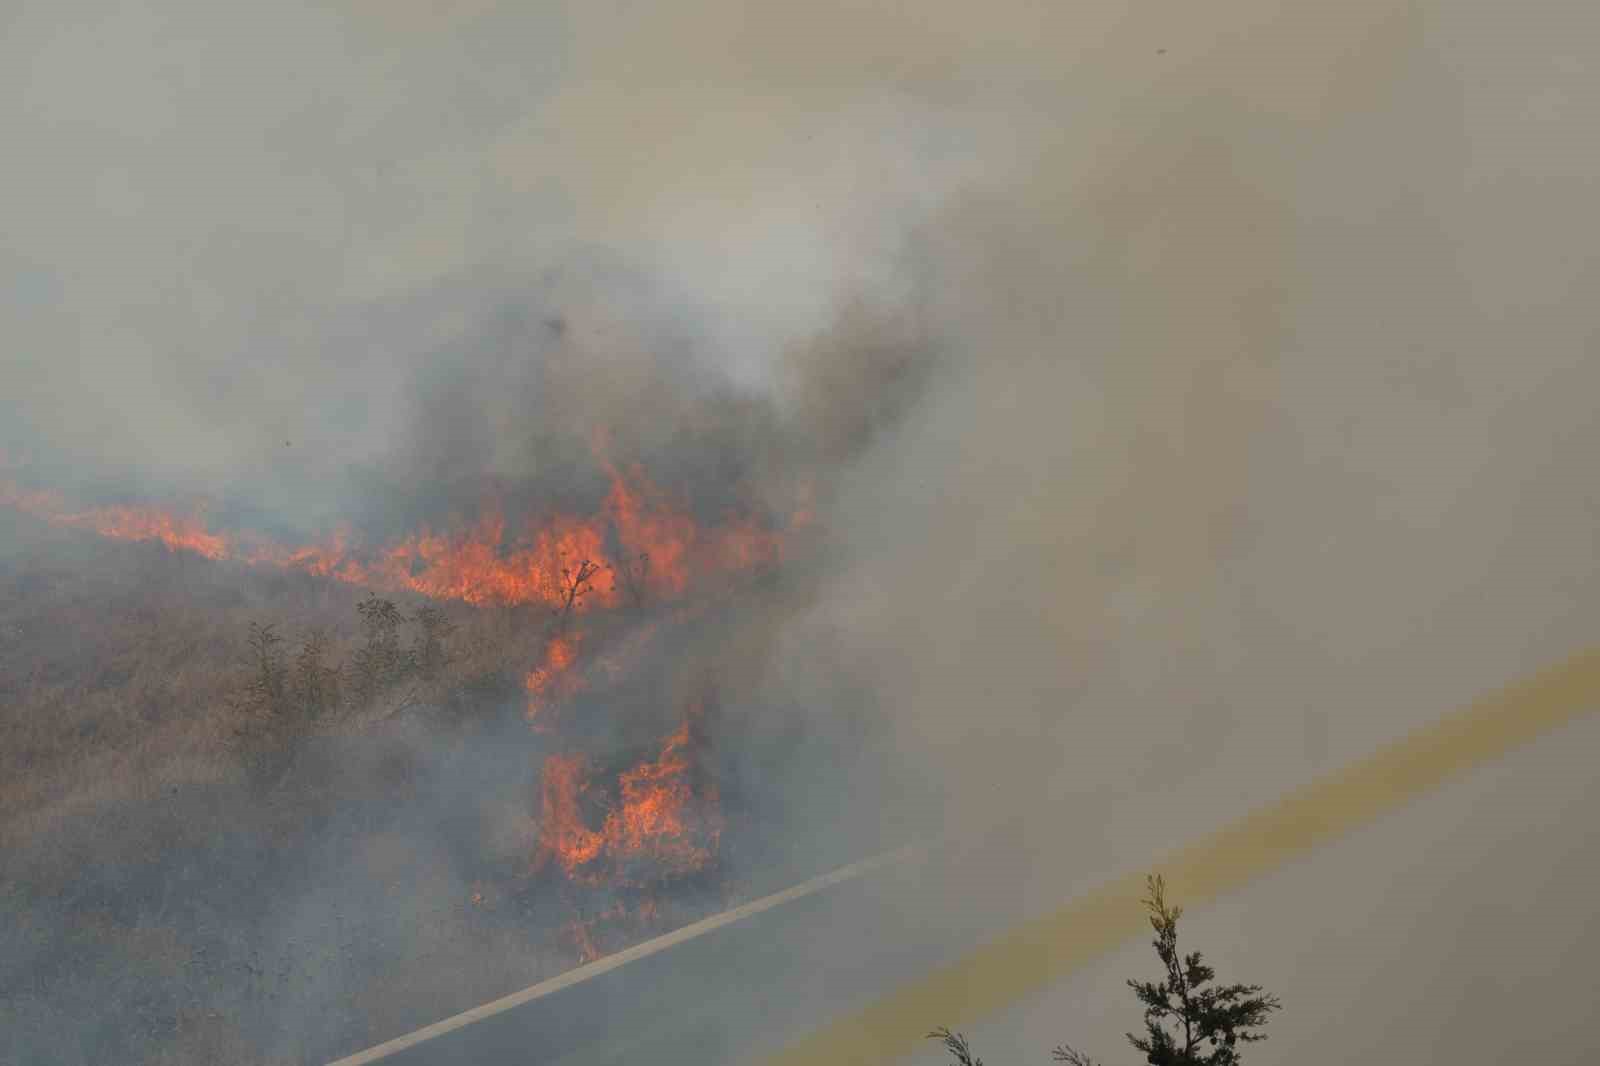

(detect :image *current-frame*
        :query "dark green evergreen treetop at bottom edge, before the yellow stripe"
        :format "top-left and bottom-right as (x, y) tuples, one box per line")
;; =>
(928, 874), (1282, 1066)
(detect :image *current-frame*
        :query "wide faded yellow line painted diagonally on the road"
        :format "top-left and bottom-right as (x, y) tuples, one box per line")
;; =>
(766, 648), (1600, 1066)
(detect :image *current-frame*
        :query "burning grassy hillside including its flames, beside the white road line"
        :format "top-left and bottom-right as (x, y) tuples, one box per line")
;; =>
(0, 472), (825, 1063)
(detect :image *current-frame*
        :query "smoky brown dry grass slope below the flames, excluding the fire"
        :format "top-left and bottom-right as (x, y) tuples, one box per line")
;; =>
(0, 512), (902, 1066)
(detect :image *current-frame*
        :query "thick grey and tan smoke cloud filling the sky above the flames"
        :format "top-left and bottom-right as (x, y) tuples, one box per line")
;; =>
(0, 0), (1600, 1056)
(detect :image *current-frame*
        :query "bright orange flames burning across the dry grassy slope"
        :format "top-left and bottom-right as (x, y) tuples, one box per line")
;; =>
(0, 445), (800, 962)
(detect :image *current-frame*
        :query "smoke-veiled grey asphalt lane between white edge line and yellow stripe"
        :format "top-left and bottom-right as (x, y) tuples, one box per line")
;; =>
(342, 832), (1022, 1066)
